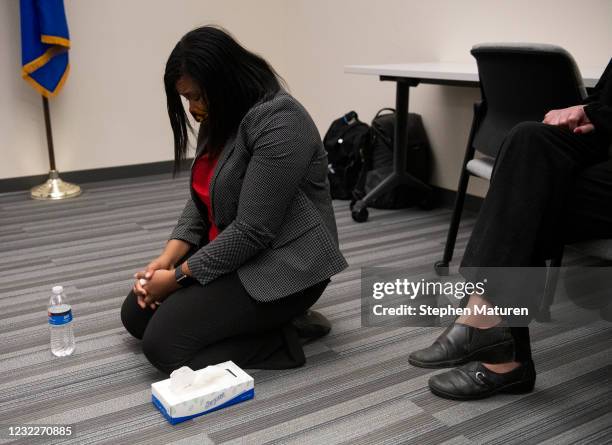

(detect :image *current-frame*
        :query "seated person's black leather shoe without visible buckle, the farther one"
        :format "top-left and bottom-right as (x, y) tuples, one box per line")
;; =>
(408, 323), (514, 368)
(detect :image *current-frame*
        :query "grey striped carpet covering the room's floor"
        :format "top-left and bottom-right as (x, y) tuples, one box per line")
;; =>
(0, 176), (612, 445)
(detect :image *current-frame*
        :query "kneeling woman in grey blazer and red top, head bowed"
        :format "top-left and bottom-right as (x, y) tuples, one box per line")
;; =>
(121, 27), (347, 373)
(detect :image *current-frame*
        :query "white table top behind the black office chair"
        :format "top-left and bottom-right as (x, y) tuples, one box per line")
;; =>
(344, 61), (605, 88)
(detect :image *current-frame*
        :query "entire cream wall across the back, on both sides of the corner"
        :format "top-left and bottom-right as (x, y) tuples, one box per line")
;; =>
(0, 0), (612, 194)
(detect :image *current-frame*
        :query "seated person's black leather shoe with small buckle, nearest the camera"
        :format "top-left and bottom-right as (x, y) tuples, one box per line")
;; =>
(429, 361), (536, 400)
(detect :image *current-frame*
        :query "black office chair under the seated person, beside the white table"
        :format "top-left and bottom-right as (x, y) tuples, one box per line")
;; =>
(435, 43), (586, 278)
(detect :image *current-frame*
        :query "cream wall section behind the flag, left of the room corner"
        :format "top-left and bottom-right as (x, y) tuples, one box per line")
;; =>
(0, 0), (285, 178)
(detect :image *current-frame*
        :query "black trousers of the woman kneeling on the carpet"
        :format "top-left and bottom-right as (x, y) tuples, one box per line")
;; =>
(121, 272), (329, 374)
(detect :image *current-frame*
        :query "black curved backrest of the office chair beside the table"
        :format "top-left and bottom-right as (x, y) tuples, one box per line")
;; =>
(471, 43), (586, 157)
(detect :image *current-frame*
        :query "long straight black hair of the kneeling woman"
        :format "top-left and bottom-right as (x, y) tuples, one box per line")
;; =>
(164, 26), (284, 175)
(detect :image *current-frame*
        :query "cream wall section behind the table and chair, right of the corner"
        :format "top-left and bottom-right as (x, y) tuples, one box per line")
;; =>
(288, 0), (612, 194)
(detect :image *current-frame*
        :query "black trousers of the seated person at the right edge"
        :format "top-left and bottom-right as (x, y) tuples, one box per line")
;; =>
(460, 122), (612, 361)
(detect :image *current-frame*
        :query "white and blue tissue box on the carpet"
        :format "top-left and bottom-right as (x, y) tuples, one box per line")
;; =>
(151, 361), (255, 425)
